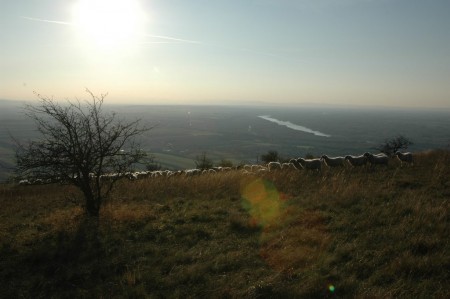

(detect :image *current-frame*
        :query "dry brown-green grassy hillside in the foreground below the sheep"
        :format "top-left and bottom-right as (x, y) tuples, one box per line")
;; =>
(0, 151), (450, 298)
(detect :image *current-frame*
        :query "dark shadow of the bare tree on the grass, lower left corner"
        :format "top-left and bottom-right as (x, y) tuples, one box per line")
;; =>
(0, 216), (109, 298)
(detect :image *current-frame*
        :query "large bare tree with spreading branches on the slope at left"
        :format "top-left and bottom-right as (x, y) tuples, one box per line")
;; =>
(16, 90), (151, 217)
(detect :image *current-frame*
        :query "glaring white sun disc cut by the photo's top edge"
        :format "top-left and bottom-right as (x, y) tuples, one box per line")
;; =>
(73, 0), (144, 50)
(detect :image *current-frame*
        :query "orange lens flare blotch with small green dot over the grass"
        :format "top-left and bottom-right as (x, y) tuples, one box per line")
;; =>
(241, 178), (334, 278)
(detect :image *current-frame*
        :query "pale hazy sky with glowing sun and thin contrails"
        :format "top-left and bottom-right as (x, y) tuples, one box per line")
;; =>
(0, 0), (450, 108)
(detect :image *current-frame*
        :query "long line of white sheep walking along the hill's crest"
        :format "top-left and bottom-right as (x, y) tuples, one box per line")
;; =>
(19, 152), (414, 185)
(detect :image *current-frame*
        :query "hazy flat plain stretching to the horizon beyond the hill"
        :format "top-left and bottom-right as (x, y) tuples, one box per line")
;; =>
(0, 101), (450, 181)
